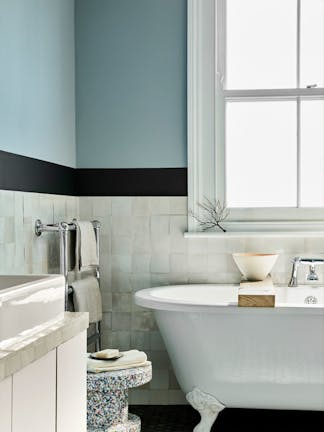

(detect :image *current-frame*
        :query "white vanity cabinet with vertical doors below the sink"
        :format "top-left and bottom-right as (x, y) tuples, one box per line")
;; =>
(0, 322), (88, 432)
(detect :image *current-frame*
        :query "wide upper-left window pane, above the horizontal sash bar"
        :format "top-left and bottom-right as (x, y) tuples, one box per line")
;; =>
(226, 0), (296, 89)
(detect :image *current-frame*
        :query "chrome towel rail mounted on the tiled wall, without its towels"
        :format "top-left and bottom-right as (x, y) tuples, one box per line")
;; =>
(35, 219), (101, 351)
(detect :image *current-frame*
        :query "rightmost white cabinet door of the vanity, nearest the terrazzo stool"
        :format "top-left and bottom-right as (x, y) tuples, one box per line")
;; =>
(57, 332), (87, 432)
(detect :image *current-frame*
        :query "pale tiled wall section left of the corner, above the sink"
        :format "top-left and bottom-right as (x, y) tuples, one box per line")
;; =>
(0, 190), (79, 274)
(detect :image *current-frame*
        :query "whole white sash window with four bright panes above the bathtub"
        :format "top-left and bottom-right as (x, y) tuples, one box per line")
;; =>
(221, 0), (324, 208)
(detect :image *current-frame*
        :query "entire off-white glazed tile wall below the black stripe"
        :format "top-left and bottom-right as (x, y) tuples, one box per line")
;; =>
(0, 191), (324, 404)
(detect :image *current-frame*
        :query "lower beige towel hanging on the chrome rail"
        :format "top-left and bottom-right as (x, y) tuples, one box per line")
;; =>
(71, 276), (102, 323)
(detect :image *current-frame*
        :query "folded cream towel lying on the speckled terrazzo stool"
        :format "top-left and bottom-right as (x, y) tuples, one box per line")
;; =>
(87, 350), (150, 373)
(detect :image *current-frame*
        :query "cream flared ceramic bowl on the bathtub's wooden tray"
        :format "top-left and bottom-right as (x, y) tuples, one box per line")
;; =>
(232, 253), (278, 281)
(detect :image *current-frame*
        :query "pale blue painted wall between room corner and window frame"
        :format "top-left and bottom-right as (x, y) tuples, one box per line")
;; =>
(76, 0), (187, 168)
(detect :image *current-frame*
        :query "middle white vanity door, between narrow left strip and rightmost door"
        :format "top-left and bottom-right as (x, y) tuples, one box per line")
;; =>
(12, 350), (56, 432)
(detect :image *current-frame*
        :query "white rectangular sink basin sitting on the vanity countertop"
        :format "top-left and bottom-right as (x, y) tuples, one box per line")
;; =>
(0, 275), (65, 342)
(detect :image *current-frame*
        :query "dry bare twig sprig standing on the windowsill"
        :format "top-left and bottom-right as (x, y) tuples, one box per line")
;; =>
(189, 196), (229, 232)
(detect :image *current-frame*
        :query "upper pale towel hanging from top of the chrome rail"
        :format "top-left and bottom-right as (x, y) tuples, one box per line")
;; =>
(75, 221), (99, 271)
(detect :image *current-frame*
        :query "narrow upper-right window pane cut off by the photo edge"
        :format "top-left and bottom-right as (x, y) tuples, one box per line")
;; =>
(300, 0), (324, 88)
